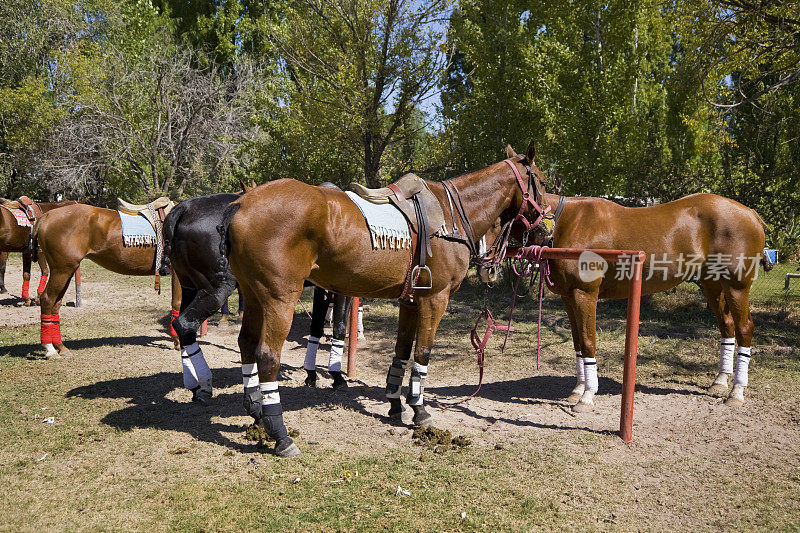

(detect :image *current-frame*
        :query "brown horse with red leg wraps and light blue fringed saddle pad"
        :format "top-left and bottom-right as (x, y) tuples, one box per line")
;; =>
(34, 204), (181, 358)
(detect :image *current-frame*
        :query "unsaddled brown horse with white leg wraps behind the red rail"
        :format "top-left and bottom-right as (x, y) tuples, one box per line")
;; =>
(481, 189), (768, 412)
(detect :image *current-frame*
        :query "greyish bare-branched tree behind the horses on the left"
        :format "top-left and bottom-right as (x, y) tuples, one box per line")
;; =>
(42, 43), (258, 199)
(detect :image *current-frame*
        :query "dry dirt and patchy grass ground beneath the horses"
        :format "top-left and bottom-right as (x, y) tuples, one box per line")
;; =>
(0, 261), (800, 531)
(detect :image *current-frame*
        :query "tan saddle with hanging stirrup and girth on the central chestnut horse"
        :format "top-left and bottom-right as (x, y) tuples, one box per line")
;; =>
(350, 174), (446, 299)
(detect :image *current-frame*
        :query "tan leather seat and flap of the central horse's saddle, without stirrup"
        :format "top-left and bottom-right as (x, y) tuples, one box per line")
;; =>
(349, 174), (446, 235)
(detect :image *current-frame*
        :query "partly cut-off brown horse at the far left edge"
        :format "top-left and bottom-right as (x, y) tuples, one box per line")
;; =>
(0, 200), (77, 305)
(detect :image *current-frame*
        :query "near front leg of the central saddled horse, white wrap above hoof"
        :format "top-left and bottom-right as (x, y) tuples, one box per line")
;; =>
(406, 292), (449, 426)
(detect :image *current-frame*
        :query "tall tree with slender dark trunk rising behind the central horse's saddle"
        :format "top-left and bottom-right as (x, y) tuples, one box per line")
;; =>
(274, 0), (448, 187)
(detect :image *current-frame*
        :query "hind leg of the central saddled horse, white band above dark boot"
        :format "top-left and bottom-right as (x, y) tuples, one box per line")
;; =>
(239, 281), (302, 457)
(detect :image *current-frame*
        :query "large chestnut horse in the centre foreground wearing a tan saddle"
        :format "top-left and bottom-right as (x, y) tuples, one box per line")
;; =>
(221, 145), (543, 456)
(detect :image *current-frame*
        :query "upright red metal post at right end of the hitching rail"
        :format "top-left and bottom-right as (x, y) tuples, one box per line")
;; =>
(619, 252), (646, 442)
